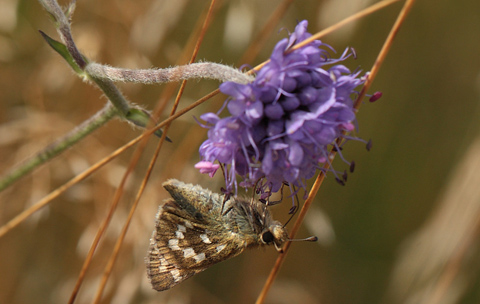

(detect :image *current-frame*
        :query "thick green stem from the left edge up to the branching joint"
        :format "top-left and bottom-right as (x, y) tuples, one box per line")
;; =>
(0, 103), (118, 191)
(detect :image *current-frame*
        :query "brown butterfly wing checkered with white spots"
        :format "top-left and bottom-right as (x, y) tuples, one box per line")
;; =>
(146, 200), (245, 291)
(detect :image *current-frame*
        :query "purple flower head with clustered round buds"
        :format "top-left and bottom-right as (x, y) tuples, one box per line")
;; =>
(198, 21), (365, 193)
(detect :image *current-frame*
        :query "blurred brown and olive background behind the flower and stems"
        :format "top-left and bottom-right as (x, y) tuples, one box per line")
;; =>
(0, 0), (480, 304)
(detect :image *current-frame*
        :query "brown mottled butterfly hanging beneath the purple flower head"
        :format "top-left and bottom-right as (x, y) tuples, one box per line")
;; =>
(145, 179), (288, 291)
